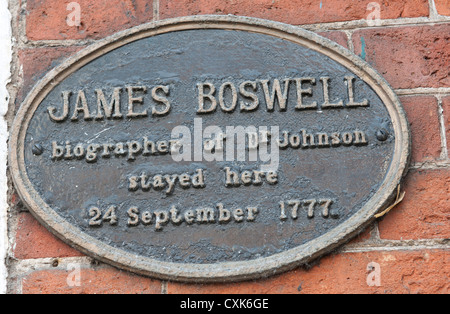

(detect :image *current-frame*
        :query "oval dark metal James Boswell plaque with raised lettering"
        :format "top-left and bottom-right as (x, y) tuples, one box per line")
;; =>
(10, 16), (410, 282)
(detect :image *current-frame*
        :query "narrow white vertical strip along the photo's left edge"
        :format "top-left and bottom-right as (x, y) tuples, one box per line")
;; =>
(0, 0), (12, 294)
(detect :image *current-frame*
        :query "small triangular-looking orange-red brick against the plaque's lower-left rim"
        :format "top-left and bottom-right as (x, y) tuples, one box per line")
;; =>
(14, 213), (83, 259)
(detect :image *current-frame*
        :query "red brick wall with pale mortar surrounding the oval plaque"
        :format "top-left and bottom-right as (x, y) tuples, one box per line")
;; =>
(8, 0), (450, 294)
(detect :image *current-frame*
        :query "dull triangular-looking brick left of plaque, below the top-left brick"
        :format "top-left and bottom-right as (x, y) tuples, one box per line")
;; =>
(17, 46), (84, 103)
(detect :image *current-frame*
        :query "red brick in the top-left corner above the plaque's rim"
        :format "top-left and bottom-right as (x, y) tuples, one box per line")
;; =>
(26, 0), (153, 40)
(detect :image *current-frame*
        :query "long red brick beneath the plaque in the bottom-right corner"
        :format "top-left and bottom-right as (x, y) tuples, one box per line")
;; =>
(168, 250), (450, 294)
